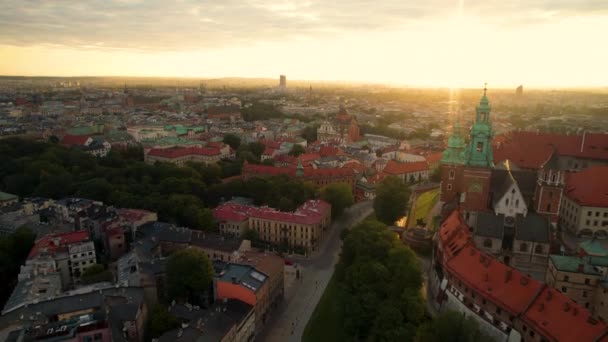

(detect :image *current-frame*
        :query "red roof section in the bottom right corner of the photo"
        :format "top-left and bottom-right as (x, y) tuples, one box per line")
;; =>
(520, 287), (606, 342)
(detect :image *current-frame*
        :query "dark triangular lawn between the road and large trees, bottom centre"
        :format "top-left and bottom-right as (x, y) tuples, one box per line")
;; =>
(302, 275), (346, 342)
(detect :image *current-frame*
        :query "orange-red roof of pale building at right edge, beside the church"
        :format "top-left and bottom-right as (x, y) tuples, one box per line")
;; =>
(566, 166), (608, 207)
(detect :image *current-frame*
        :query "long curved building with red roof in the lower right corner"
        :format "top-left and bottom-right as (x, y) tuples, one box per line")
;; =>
(435, 210), (608, 342)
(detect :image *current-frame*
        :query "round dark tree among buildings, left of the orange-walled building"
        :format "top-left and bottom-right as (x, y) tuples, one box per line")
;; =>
(167, 248), (215, 302)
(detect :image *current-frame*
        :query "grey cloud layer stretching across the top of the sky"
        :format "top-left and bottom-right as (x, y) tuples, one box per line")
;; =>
(0, 0), (608, 51)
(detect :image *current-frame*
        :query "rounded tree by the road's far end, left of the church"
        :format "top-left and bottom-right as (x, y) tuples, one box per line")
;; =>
(374, 176), (410, 225)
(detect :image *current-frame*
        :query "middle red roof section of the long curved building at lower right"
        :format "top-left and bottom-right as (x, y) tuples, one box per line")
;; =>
(446, 244), (543, 315)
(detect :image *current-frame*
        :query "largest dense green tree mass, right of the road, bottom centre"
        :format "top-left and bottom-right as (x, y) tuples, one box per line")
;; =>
(336, 220), (425, 341)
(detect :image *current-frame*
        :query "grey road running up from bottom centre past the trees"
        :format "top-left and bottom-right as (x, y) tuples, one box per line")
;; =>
(257, 201), (373, 342)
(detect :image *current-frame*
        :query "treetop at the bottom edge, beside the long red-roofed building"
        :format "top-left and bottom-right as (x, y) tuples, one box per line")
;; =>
(416, 311), (491, 342)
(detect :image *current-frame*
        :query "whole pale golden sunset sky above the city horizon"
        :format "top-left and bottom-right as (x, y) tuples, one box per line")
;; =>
(0, 0), (608, 87)
